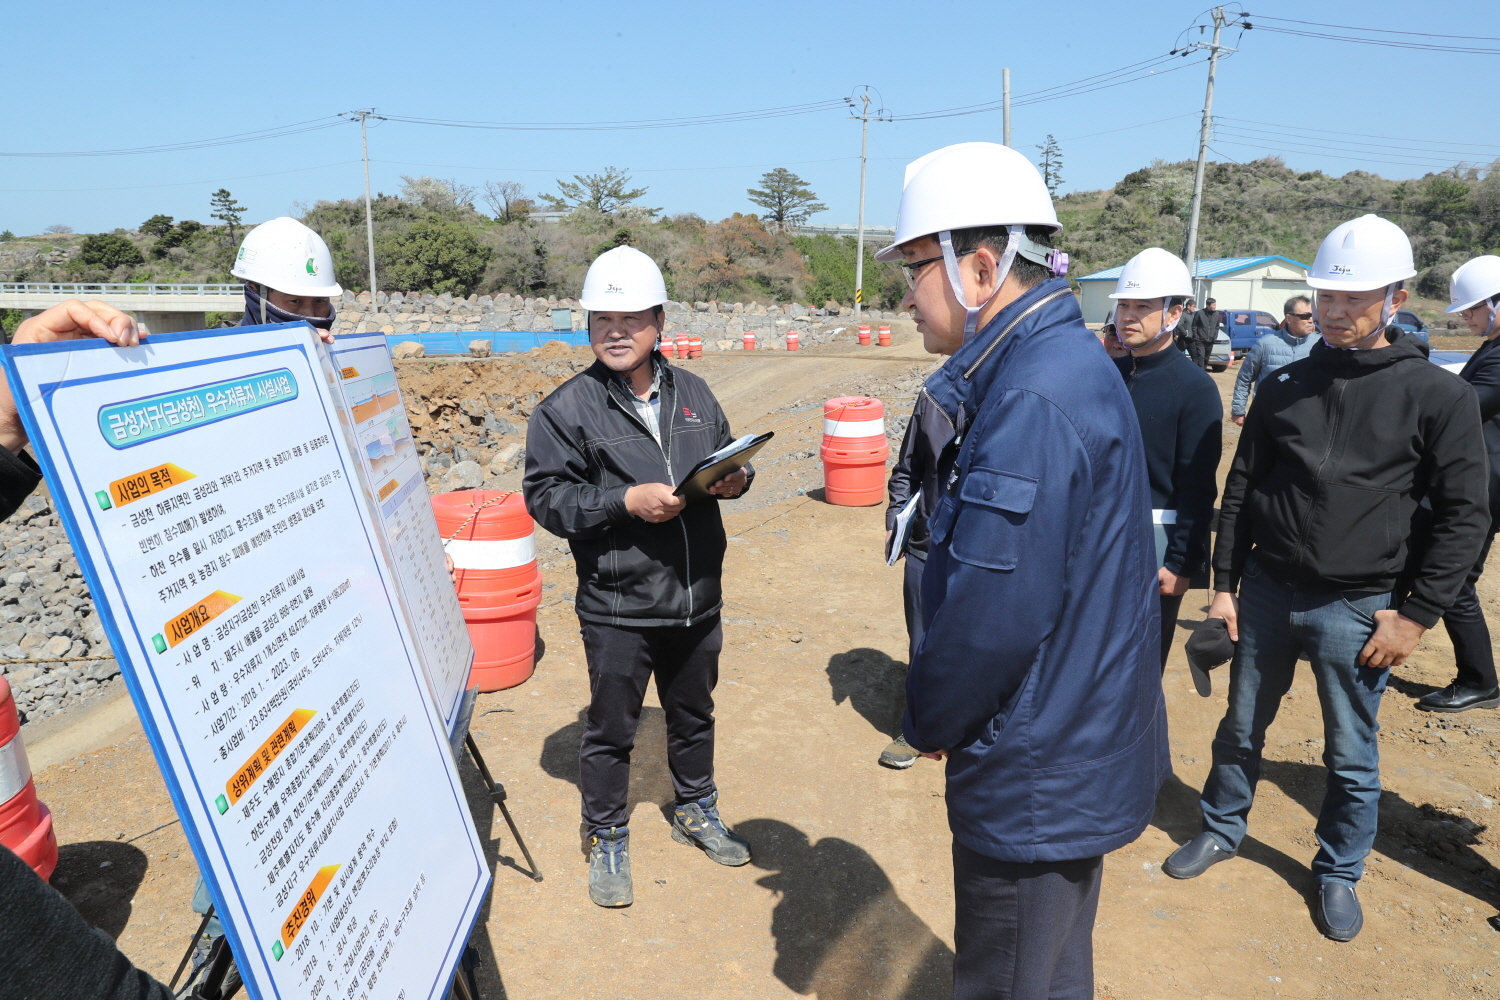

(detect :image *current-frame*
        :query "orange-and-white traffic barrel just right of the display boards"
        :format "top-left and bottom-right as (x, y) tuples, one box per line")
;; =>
(432, 490), (542, 691)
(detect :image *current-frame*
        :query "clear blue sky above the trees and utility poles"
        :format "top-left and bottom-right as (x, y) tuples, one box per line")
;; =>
(0, 0), (1500, 234)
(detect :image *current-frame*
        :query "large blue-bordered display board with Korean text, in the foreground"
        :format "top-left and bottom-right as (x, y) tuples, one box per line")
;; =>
(5, 325), (489, 1000)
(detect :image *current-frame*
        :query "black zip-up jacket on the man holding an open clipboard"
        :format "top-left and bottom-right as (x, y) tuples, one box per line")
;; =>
(522, 358), (755, 627)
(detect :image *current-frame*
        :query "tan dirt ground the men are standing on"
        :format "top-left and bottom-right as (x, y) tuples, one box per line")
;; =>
(26, 328), (1500, 1000)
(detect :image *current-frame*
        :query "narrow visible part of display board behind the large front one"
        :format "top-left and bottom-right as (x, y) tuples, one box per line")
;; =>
(327, 333), (474, 736)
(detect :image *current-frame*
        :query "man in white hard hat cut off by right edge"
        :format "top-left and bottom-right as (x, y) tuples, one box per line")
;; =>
(1416, 255), (1500, 714)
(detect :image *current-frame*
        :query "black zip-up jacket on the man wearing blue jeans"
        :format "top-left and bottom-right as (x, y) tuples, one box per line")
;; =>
(1214, 334), (1490, 628)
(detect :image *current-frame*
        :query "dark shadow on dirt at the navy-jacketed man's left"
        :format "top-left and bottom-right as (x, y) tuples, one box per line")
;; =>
(735, 819), (953, 1000)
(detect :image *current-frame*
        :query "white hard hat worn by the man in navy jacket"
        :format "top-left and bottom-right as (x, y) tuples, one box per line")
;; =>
(875, 142), (1062, 262)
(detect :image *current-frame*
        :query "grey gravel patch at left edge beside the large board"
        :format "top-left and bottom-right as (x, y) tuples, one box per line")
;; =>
(0, 490), (120, 723)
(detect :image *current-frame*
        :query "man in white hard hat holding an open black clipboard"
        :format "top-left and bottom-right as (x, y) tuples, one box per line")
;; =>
(524, 246), (753, 907)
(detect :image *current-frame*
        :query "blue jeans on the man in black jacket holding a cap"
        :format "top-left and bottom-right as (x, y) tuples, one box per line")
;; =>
(1203, 558), (1391, 882)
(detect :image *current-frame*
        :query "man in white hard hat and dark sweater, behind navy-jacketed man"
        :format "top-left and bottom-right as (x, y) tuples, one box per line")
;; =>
(1110, 246), (1224, 677)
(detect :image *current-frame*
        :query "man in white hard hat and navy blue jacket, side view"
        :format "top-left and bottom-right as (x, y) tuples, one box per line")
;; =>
(878, 142), (1170, 1000)
